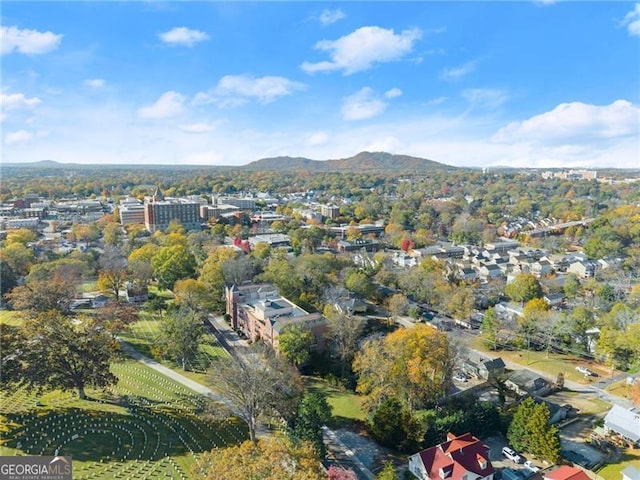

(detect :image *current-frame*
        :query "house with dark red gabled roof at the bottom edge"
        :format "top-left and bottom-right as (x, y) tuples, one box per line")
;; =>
(409, 433), (494, 480)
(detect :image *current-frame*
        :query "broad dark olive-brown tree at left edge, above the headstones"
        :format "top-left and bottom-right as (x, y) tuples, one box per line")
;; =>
(1, 311), (119, 399)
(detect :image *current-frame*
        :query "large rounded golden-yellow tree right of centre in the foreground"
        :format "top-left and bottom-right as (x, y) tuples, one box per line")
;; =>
(353, 325), (457, 410)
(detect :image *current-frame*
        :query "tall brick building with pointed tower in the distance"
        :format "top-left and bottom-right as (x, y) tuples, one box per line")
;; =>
(144, 187), (200, 233)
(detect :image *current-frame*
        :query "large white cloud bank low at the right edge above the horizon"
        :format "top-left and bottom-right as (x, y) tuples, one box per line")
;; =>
(492, 100), (640, 145)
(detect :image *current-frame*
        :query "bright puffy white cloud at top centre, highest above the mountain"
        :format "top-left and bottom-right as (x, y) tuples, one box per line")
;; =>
(301, 26), (422, 75)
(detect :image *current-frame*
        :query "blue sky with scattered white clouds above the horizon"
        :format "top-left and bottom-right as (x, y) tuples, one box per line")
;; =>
(0, 0), (640, 168)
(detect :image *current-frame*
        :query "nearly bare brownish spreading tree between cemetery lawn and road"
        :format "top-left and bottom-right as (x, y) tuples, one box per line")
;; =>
(209, 346), (302, 444)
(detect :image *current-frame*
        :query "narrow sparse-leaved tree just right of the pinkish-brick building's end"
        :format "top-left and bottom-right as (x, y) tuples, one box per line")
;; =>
(323, 305), (364, 378)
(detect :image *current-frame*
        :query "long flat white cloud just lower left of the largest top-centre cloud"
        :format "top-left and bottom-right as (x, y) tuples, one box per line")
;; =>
(193, 75), (306, 106)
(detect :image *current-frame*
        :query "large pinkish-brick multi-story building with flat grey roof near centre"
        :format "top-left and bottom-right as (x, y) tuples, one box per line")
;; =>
(225, 284), (327, 351)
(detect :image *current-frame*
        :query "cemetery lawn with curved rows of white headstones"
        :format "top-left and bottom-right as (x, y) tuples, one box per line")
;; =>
(0, 361), (247, 479)
